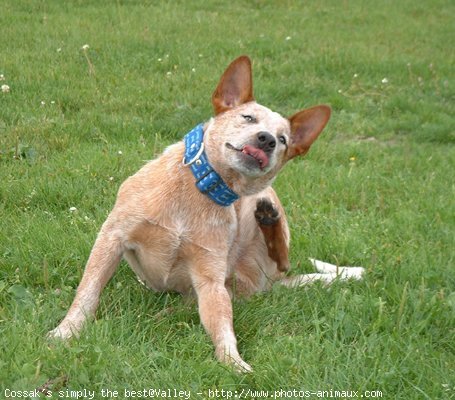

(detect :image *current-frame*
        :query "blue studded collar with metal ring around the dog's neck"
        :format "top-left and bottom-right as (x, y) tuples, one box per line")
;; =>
(183, 124), (239, 207)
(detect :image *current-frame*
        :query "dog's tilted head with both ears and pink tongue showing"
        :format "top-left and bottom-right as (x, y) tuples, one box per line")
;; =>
(205, 56), (330, 195)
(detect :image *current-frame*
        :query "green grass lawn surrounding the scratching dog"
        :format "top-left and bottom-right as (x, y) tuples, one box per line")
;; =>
(0, 0), (455, 399)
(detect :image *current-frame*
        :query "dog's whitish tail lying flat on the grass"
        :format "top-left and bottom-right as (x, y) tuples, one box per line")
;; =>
(280, 258), (365, 287)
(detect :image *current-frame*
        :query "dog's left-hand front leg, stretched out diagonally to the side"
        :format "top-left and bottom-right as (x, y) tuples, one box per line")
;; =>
(48, 220), (122, 339)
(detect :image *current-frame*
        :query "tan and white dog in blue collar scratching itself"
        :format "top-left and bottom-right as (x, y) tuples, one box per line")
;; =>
(48, 56), (364, 371)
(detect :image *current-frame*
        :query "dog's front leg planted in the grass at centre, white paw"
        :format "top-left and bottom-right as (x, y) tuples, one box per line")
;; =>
(191, 250), (252, 372)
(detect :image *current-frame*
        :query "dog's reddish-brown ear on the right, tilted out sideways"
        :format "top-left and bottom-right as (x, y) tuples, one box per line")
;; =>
(288, 105), (331, 160)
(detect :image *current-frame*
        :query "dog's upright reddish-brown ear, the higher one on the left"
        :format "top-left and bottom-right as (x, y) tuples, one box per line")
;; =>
(212, 56), (254, 115)
